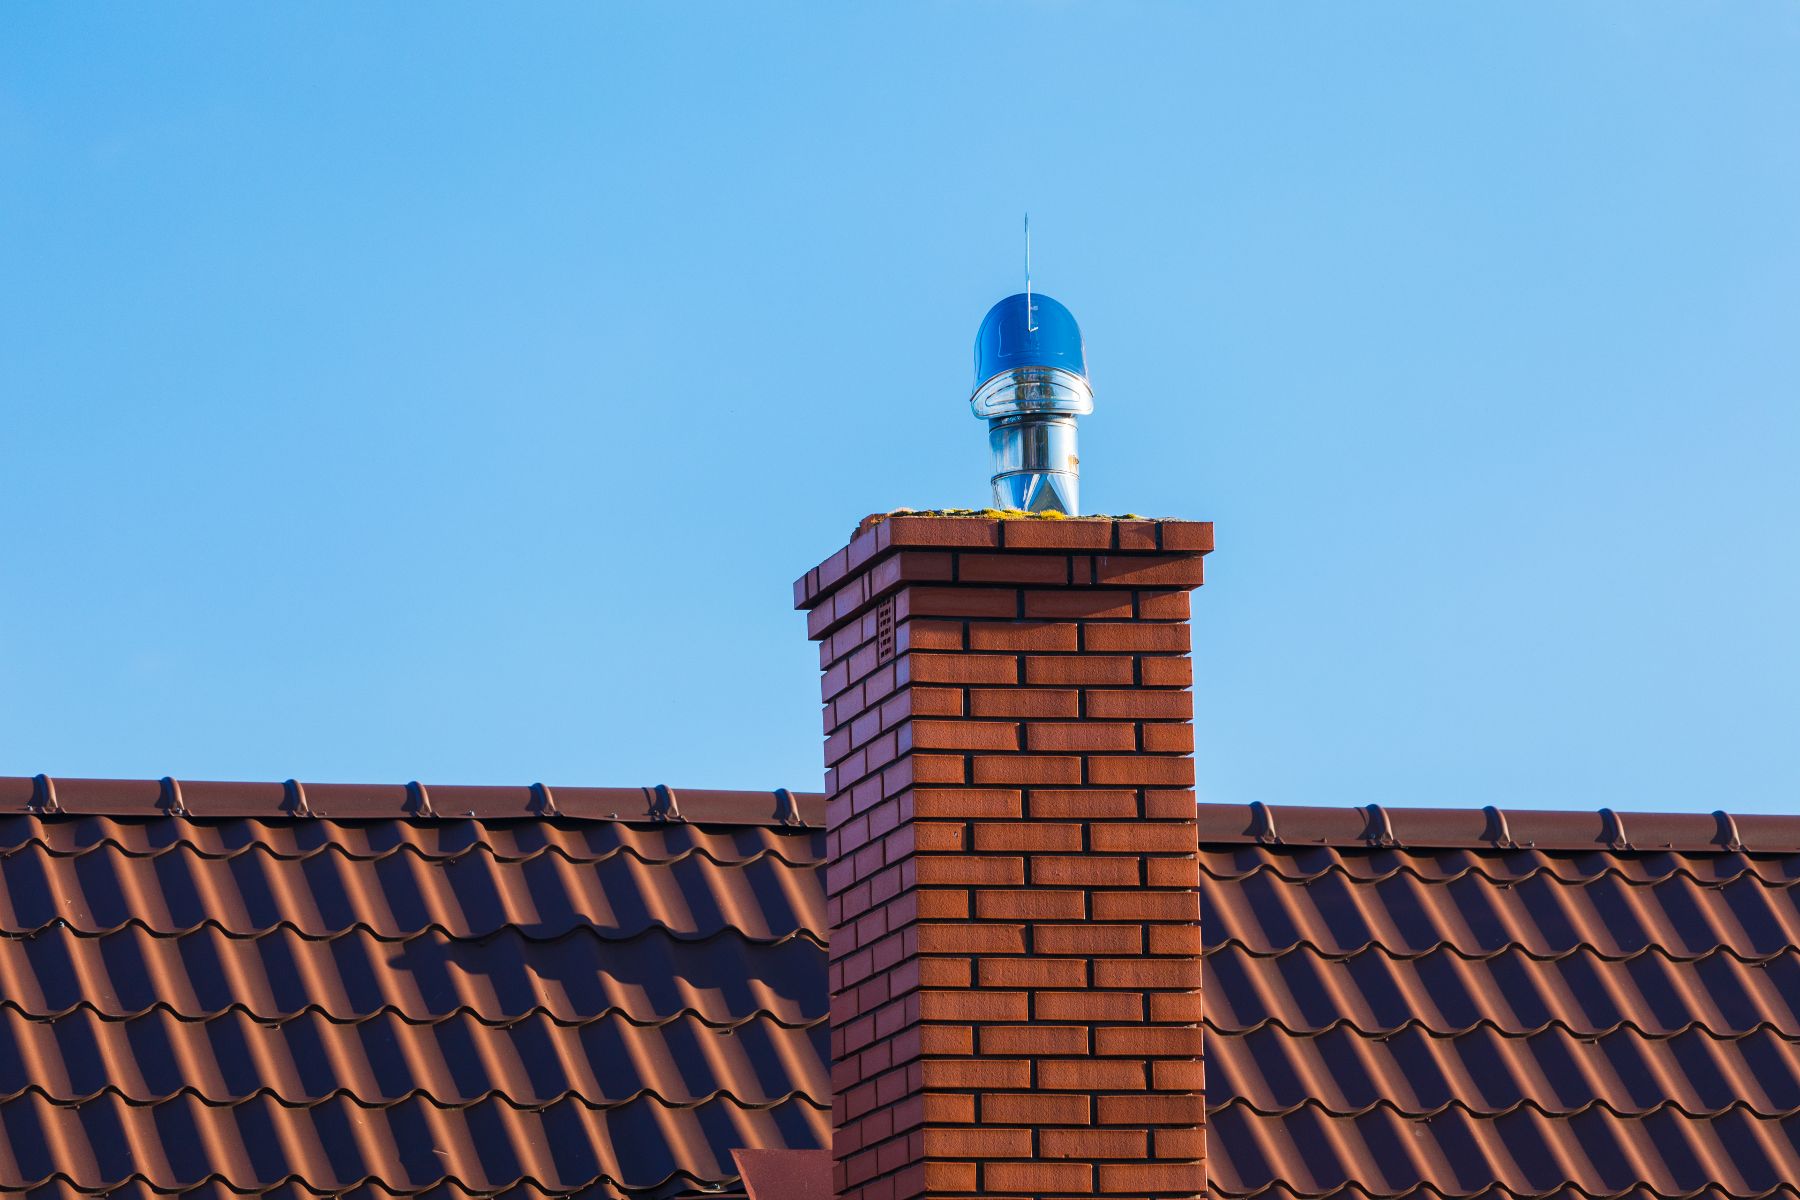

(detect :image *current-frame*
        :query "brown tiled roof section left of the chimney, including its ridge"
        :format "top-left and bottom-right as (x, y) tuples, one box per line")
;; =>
(0, 777), (830, 1196)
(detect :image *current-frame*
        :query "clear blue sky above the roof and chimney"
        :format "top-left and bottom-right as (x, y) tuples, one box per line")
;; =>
(0, 0), (1800, 811)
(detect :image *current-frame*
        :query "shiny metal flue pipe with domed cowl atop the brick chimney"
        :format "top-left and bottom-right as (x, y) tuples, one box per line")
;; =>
(968, 291), (1094, 516)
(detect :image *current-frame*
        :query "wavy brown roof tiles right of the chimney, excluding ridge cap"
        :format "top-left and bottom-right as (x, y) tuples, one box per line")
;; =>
(1201, 841), (1800, 1200)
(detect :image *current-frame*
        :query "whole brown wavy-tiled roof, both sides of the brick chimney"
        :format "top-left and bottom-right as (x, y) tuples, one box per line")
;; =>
(0, 779), (1800, 1200)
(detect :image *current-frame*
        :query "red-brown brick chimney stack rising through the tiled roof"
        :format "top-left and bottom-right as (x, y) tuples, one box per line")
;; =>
(794, 515), (1213, 1200)
